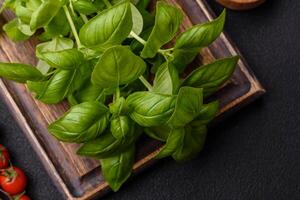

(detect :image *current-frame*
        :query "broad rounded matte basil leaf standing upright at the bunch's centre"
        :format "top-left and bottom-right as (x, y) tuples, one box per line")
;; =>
(92, 46), (146, 88)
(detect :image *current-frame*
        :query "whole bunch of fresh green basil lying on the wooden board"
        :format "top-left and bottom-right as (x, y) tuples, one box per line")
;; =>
(0, 0), (239, 191)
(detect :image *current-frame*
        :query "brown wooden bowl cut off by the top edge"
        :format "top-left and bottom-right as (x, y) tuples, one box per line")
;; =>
(217, 0), (266, 10)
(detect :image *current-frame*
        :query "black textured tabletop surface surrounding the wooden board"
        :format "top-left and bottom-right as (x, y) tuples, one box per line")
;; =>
(0, 0), (300, 200)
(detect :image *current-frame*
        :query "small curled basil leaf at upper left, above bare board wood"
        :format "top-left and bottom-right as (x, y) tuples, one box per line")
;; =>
(3, 19), (33, 42)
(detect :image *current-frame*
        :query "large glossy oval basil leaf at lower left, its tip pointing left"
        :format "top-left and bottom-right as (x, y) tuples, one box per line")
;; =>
(48, 102), (109, 143)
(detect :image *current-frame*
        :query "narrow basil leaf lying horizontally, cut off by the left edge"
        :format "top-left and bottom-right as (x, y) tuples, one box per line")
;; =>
(0, 63), (45, 83)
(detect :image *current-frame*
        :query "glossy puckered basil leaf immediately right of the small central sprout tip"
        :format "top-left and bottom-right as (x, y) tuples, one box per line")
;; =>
(126, 92), (175, 127)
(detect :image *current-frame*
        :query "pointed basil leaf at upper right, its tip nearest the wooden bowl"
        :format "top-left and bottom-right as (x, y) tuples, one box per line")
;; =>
(174, 10), (226, 50)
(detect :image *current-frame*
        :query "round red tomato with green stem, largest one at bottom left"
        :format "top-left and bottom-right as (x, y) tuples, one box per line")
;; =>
(0, 167), (27, 195)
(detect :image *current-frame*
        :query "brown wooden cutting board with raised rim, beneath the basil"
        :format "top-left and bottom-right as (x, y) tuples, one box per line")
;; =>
(0, 0), (265, 200)
